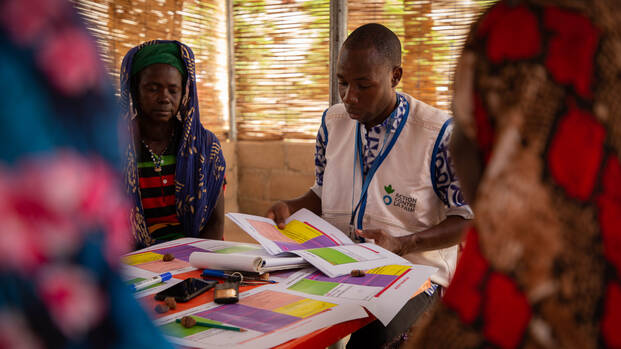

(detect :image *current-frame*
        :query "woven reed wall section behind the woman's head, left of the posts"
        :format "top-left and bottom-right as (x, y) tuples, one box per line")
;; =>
(73, 0), (229, 138)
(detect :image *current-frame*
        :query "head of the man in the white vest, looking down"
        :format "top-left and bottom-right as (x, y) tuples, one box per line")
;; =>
(336, 23), (403, 127)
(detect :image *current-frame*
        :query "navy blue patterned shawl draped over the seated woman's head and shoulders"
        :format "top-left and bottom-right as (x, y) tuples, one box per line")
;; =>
(121, 40), (226, 247)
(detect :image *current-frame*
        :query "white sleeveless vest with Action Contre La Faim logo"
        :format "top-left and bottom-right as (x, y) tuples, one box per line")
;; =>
(321, 94), (457, 286)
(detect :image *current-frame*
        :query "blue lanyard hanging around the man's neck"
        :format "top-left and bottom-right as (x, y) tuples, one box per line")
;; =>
(349, 95), (410, 236)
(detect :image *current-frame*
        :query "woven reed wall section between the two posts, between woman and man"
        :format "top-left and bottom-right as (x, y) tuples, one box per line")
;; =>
(233, 0), (330, 139)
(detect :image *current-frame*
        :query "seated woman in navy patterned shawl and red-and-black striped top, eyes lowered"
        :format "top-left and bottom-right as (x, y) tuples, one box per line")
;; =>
(121, 41), (225, 248)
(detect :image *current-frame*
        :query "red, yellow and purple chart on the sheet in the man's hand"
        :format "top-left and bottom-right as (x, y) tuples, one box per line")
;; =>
(247, 219), (338, 251)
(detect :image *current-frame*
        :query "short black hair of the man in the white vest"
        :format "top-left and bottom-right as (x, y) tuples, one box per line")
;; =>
(343, 23), (401, 67)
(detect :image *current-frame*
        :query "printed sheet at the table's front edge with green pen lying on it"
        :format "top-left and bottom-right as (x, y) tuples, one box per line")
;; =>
(156, 286), (367, 349)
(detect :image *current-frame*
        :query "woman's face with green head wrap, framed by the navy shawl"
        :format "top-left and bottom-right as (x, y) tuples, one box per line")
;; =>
(131, 43), (187, 123)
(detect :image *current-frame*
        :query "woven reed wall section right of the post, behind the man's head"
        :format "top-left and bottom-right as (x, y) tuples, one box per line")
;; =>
(347, 0), (495, 112)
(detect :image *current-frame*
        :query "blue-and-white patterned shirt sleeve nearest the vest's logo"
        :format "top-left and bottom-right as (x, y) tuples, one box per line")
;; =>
(430, 119), (474, 219)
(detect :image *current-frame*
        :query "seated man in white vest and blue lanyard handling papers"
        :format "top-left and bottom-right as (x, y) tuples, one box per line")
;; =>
(267, 24), (472, 347)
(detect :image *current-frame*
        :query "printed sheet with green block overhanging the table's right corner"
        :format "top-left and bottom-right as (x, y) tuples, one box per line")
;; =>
(275, 263), (437, 325)
